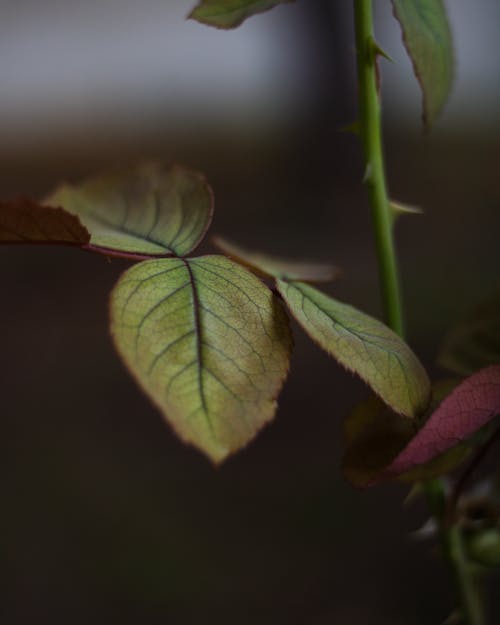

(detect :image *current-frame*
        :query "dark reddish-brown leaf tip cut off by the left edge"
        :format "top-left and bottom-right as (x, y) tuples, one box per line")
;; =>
(0, 198), (90, 246)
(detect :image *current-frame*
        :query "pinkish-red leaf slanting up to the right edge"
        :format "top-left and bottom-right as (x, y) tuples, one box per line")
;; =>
(379, 365), (500, 479)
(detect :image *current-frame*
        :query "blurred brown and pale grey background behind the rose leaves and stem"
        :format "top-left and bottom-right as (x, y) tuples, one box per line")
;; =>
(0, 0), (500, 625)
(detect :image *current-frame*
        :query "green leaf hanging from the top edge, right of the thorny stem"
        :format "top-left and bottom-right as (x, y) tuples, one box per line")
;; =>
(392, 0), (454, 127)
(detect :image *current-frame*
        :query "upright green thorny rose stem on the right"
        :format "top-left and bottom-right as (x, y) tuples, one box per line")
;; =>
(354, 0), (484, 625)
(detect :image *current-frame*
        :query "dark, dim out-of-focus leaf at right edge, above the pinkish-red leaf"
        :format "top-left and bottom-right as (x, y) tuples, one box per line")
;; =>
(438, 289), (500, 375)
